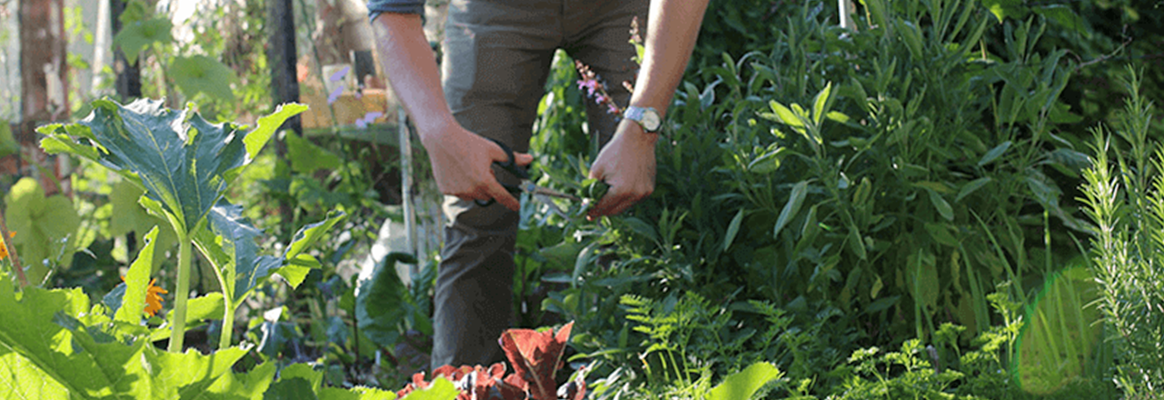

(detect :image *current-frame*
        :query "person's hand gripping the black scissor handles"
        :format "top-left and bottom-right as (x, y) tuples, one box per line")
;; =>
(421, 126), (533, 212)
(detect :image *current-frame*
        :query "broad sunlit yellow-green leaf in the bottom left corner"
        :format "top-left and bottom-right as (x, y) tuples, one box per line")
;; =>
(0, 276), (246, 399)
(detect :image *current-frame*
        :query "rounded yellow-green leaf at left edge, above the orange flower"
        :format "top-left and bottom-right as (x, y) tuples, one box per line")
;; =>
(5, 178), (80, 284)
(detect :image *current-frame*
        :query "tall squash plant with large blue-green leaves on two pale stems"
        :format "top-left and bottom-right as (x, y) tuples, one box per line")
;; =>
(38, 99), (343, 351)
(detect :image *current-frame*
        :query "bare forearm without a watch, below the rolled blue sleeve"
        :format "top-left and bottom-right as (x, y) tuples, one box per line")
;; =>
(372, 13), (456, 142)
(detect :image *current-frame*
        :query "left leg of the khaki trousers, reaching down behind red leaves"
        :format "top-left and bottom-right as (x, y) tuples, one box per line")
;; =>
(432, 0), (560, 369)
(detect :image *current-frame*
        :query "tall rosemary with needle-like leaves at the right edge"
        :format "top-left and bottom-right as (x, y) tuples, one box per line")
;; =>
(1083, 71), (1164, 398)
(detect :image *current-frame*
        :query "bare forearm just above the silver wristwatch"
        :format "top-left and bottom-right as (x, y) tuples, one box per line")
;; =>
(631, 0), (708, 114)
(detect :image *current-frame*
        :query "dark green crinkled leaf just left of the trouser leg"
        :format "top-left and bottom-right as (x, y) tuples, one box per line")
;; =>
(356, 252), (427, 347)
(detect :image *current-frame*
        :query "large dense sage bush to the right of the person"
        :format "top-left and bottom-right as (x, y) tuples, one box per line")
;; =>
(517, 0), (1117, 394)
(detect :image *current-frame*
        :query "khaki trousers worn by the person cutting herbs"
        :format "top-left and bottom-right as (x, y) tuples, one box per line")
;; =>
(432, 0), (648, 369)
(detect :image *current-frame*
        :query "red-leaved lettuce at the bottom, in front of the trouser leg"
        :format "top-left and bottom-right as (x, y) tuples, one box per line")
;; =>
(396, 322), (585, 400)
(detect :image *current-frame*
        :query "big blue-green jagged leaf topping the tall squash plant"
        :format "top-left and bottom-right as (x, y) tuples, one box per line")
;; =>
(37, 99), (301, 234)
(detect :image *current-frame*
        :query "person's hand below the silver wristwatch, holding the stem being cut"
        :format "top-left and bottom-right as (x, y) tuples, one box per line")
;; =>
(587, 120), (659, 221)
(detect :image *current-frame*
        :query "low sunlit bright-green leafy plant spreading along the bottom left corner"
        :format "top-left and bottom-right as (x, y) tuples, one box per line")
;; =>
(0, 263), (395, 399)
